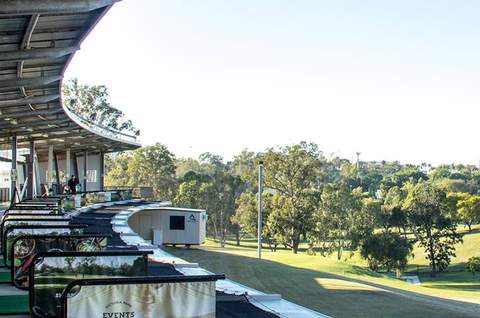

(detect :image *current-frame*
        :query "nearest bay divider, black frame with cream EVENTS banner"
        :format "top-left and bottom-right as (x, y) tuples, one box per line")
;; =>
(61, 275), (225, 318)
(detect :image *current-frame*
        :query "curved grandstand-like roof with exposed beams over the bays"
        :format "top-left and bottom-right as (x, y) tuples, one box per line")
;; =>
(0, 0), (140, 152)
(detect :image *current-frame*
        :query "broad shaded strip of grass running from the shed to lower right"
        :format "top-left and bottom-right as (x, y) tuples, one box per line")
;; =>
(167, 248), (478, 318)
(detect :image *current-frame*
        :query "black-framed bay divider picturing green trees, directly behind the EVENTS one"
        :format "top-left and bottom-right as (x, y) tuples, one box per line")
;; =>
(29, 251), (152, 317)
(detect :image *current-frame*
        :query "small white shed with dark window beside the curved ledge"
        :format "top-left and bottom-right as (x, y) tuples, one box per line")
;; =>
(128, 207), (207, 246)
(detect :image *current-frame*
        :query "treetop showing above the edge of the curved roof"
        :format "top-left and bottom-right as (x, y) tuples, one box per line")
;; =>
(62, 78), (140, 136)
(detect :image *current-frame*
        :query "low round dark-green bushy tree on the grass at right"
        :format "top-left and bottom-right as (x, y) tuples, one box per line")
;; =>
(360, 232), (413, 271)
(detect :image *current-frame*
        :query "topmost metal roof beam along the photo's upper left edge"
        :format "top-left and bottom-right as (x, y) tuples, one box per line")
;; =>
(0, 0), (117, 15)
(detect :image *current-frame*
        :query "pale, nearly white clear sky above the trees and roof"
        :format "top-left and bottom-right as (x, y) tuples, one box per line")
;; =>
(67, 0), (480, 164)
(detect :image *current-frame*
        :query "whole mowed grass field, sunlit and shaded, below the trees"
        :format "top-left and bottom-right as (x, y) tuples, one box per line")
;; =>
(168, 227), (480, 318)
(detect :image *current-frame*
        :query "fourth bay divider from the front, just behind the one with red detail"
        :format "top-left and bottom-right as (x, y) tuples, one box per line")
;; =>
(2, 224), (87, 267)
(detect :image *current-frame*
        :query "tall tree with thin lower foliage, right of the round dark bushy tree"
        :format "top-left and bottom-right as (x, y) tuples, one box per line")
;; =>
(403, 182), (463, 276)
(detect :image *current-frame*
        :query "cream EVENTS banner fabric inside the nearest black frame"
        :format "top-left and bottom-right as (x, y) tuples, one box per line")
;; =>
(67, 281), (215, 318)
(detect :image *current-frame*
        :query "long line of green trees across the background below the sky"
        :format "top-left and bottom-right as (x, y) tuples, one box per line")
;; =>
(106, 142), (480, 274)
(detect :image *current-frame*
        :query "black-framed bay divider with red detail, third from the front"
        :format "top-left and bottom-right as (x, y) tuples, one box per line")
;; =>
(10, 234), (112, 289)
